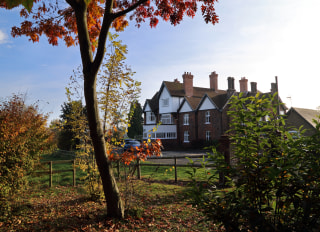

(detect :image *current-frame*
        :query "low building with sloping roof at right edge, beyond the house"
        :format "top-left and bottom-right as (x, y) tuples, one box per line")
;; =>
(286, 107), (320, 136)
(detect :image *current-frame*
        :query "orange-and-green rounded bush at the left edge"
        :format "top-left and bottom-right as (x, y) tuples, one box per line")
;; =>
(0, 95), (52, 220)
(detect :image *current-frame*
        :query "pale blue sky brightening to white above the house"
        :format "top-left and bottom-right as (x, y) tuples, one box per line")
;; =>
(0, 0), (320, 122)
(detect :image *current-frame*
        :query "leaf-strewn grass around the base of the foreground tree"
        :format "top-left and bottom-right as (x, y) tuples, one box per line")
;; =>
(0, 180), (219, 231)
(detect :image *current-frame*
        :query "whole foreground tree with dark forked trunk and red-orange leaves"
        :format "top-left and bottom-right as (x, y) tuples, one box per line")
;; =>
(0, 0), (218, 217)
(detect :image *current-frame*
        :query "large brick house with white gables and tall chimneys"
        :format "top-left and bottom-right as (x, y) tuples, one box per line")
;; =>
(143, 72), (284, 148)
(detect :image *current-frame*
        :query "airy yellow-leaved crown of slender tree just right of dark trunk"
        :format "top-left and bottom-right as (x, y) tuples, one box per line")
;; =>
(98, 33), (141, 132)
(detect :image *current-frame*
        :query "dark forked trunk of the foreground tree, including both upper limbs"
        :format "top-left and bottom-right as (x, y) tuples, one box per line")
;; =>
(66, 0), (124, 218)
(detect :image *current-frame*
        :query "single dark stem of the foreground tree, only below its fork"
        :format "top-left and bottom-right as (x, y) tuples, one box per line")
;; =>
(84, 74), (124, 218)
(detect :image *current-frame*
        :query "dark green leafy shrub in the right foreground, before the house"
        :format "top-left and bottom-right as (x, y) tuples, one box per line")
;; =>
(191, 95), (320, 231)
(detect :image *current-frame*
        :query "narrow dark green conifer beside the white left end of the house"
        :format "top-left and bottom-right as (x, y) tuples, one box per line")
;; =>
(128, 101), (143, 139)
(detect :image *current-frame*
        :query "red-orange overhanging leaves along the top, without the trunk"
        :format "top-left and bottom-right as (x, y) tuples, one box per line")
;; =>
(4, 0), (219, 50)
